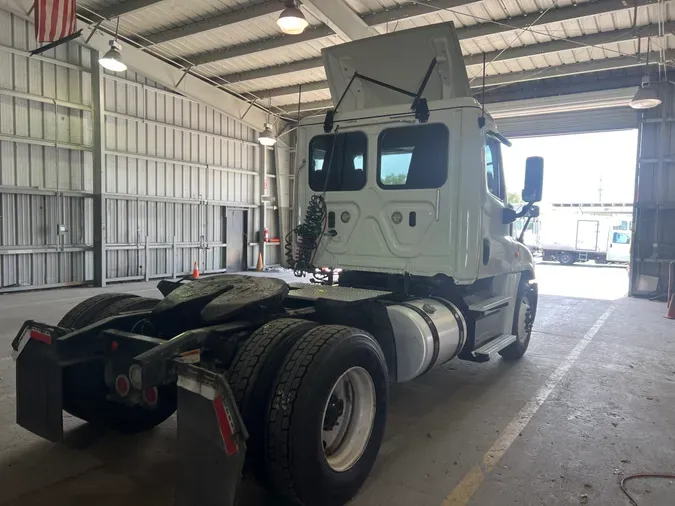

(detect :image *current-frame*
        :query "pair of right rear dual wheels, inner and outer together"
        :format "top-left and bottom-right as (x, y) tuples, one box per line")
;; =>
(229, 319), (389, 506)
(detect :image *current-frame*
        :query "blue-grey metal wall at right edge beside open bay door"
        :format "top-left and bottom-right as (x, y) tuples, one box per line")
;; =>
(631, 83), (675, 295)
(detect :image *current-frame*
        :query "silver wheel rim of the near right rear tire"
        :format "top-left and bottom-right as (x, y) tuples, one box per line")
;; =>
(321, 367), (376, 472)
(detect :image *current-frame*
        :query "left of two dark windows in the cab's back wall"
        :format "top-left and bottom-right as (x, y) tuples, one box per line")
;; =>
(308, 132), (368, 192)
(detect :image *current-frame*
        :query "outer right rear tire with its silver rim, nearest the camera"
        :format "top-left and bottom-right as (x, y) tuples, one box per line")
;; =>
(266, 325), (389, 506)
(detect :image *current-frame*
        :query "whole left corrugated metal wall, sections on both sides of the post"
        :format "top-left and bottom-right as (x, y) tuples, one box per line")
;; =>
(0, 10), (270, 291)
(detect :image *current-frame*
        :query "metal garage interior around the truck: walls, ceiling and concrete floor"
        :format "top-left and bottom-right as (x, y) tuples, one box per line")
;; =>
(0, 0), (675, 506)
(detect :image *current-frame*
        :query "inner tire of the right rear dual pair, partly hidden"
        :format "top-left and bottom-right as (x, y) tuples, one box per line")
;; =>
(228, 318), (317, 476)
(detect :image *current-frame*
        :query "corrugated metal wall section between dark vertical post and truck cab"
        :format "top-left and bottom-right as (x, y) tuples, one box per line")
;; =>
(104, 72), (260, 281)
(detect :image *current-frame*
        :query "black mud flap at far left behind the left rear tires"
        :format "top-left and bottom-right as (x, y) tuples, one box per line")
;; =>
(16, 336), (63, 443)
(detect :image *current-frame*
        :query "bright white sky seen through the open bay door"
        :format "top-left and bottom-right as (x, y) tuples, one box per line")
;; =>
(502, 130), (637, 203)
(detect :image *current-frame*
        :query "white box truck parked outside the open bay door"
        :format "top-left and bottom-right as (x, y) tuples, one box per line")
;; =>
(541, 212), (631, 265)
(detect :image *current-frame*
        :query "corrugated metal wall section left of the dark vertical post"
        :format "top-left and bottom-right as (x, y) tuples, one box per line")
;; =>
(0, 11), (93, 291)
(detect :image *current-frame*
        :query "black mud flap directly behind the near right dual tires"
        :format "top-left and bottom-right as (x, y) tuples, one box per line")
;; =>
(174, 364), (247, 506)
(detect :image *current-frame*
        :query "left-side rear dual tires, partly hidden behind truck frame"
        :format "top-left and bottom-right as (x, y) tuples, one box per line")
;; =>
(59, 293), (176, 434)
